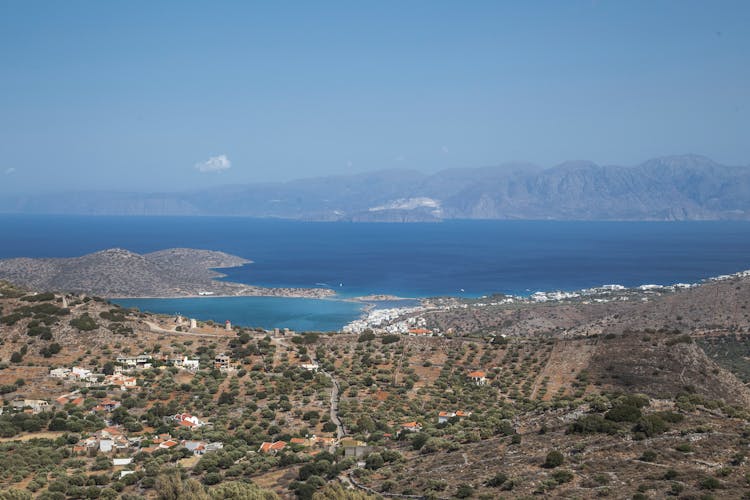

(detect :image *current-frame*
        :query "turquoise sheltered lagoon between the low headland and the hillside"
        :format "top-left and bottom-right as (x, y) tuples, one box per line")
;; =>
(113, 297), (363, 332)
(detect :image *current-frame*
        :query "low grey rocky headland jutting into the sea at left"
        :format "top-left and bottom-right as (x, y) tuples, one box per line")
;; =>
(0, 248), (333, 297)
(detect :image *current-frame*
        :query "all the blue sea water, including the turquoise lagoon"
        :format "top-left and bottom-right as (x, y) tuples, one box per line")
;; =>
(0, 215), (750, 331)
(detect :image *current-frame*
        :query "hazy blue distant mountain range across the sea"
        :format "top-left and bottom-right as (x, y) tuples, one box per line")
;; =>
(0, 155), (750, 222)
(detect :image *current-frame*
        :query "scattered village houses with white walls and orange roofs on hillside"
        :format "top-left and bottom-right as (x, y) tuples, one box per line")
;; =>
(0, 312), (487, 492)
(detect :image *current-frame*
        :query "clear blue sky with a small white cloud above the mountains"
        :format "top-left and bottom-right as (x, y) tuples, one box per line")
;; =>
(0, 0), (750, 194)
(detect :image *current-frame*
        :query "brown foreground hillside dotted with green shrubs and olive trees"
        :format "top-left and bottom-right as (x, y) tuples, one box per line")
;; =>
(0, 276), (750, 499)
